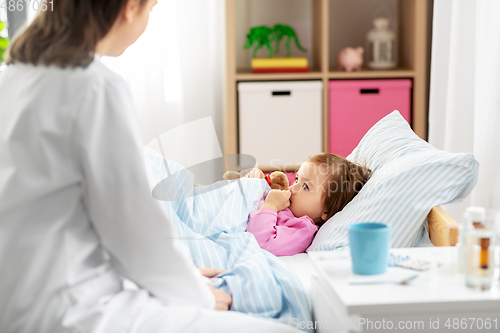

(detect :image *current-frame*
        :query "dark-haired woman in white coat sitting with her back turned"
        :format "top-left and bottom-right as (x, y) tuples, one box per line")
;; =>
(0, 0), (291, 333)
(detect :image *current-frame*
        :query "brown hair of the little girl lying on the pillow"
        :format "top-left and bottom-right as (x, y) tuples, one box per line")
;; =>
(307, 153), (371, 227)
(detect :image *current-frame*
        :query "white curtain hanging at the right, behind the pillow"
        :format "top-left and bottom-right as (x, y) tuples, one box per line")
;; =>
(429, 0), (500, 221)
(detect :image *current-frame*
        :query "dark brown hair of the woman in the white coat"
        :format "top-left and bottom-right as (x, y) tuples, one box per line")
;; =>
(6, 0), (148, 68)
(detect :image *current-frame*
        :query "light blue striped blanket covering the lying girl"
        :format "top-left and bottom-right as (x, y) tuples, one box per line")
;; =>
(145, 148), (311, 327)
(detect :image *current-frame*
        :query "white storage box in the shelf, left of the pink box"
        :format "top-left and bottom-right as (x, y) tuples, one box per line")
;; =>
(238, 81), (323, 168)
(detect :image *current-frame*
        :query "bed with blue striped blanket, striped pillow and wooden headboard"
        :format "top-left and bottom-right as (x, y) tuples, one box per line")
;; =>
(145, 111), (478, 325)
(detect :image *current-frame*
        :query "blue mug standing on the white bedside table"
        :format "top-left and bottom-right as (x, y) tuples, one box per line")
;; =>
(349, 223), (391, 275)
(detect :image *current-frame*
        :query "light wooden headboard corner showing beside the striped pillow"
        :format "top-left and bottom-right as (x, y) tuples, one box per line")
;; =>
(427, 206), (458, 246)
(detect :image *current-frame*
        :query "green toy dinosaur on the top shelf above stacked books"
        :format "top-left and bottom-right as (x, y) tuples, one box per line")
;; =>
(243, 24), (307, 58)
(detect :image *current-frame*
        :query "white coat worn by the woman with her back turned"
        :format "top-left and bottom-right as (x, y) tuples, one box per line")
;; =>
(0, 54), (221, 333)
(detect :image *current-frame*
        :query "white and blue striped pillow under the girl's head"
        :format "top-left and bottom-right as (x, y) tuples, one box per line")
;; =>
(307, 111), (479, 251)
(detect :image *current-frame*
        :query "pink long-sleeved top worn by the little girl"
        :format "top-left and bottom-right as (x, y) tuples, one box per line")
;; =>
(247, 201), (318, 256)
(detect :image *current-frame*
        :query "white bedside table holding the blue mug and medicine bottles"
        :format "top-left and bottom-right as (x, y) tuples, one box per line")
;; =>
(309, 247), (500, 333)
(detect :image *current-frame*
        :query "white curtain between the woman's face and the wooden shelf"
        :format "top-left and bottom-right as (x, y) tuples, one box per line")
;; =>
(103, 0), (225, 182)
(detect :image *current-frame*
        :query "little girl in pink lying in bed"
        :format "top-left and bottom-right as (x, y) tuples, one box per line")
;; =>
(247, 153), (371, 256)
